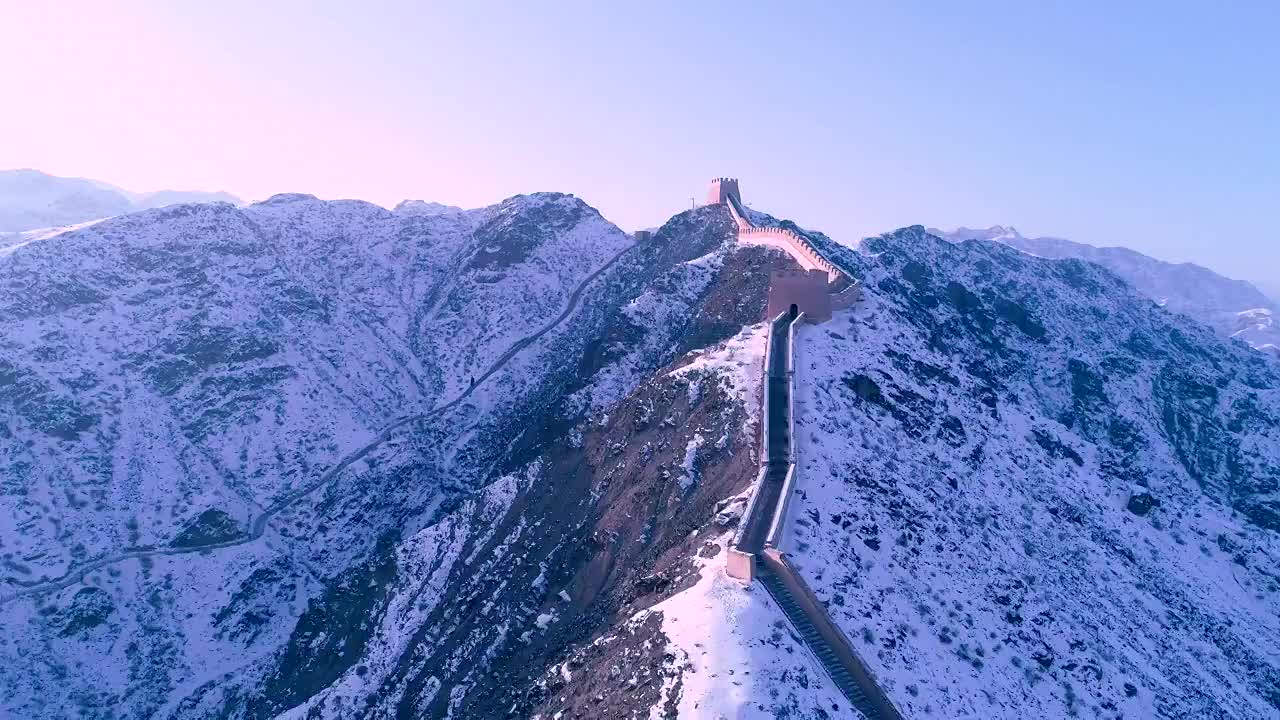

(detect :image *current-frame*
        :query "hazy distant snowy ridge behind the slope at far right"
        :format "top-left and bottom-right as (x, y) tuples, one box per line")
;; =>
(929, 225), (1280, 355)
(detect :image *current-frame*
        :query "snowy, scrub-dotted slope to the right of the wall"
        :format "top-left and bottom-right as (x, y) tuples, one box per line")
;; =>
(787, 227), (1280, 717)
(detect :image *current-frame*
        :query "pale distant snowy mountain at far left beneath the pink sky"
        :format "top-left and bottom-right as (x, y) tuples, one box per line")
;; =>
(0, 170), (239, 233)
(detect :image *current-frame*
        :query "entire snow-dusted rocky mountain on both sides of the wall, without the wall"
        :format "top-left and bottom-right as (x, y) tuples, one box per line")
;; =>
(0, 193), (1280, 720)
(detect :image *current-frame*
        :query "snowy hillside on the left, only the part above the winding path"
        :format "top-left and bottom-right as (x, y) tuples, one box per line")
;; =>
(0, 190), (628, 578)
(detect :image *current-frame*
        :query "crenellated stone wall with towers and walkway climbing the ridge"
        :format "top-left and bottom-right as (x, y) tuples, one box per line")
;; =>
(707, 178), (901, 720)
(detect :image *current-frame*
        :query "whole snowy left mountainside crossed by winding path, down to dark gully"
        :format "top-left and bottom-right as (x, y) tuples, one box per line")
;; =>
(0, 188), (631, 716)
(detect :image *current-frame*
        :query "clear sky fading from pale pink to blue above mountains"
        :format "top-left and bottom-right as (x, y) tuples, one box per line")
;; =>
(0, 0), (1280, 292)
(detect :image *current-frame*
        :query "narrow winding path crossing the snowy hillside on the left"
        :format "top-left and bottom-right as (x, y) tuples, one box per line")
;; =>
(0, 238), (636, 607)
